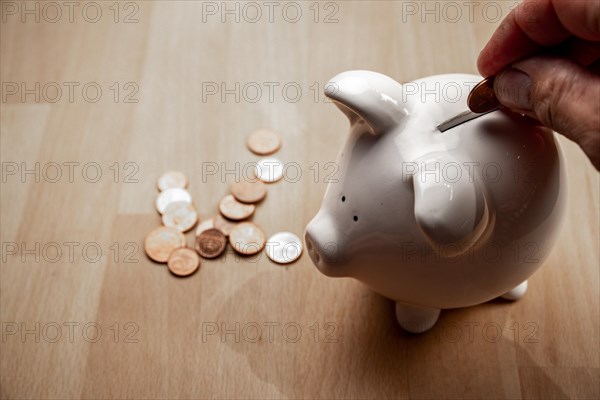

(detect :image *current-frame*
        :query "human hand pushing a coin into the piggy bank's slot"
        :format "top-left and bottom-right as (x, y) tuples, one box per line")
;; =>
(477, 0), (600, 170)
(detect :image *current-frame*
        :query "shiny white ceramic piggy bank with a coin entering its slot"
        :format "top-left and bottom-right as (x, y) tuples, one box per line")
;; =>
(305, 71), (566, 333)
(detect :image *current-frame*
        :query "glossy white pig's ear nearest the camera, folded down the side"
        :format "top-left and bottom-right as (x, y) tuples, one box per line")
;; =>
(412, 157), (495, 257)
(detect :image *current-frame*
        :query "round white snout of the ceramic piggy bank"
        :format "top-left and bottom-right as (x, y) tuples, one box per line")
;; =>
(304, 212), (344, 276)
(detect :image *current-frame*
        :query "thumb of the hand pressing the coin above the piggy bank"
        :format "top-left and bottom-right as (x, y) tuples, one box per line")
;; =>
(494, 56), (600, 170)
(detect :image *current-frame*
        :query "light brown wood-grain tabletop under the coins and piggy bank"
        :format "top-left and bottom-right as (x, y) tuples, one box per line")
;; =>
(0, 1), (600, 399)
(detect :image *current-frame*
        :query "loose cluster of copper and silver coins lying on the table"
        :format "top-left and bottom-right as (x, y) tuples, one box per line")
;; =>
(144, 129), (302, 276)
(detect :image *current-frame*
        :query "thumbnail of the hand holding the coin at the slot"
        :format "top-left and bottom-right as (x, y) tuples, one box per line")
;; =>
(494, 68), (533, 111)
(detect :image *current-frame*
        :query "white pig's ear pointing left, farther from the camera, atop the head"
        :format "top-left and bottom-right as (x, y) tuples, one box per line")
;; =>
(325, 71), (408, 134)
